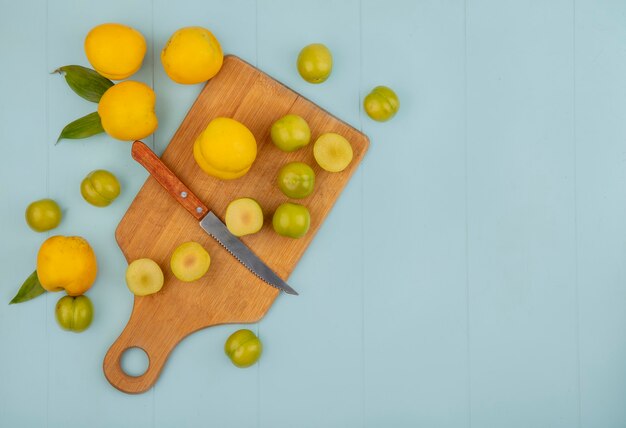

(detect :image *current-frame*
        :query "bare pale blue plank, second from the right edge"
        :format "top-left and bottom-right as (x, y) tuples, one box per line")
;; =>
(466, 0), (579, 428)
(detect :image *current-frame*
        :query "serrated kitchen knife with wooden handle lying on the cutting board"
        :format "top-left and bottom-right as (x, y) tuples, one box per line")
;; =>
(131, 141), (298, 296)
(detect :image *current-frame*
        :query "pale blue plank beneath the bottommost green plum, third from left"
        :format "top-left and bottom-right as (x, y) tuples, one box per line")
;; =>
(149, 0), (260, 428)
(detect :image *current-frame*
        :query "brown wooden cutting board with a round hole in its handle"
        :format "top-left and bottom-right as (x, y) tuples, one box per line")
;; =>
(103, 56), (369, 393)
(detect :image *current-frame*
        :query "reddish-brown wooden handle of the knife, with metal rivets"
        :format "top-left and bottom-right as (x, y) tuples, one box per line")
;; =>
(130, 141), (209, 220)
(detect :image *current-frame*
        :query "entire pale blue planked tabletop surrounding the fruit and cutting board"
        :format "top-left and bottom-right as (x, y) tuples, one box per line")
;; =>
(0, 0), (626, 428)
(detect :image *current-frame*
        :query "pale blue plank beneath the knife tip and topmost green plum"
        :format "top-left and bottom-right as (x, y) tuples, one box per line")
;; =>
(252, 0), (364, 428)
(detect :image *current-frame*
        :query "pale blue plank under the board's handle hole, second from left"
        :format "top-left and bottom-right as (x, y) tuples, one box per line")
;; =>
(44, 0), (158, 427)
